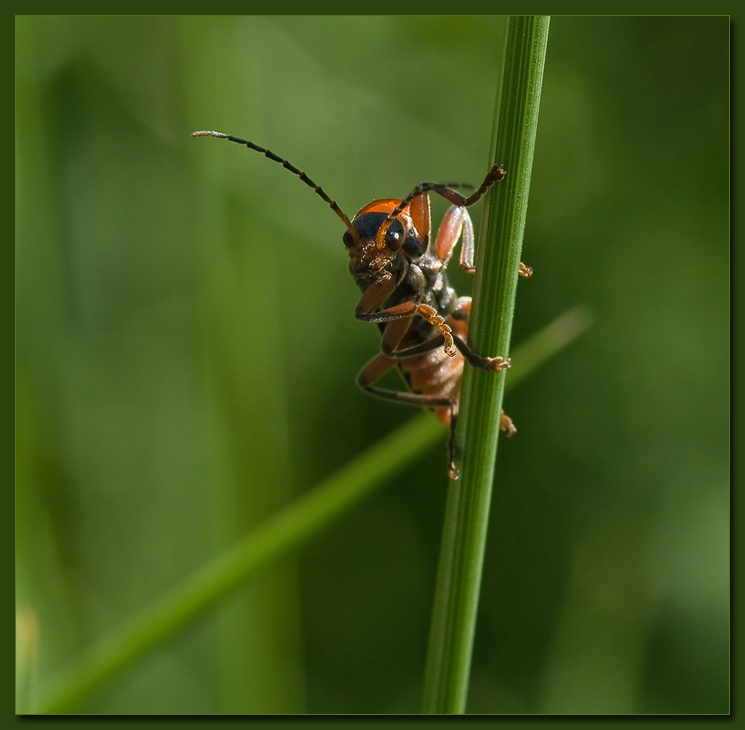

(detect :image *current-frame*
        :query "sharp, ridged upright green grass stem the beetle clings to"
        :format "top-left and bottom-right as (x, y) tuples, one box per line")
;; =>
(423, 16), (549, 714)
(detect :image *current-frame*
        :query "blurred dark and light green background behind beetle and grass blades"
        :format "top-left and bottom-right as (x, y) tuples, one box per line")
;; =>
(16, 16), (729, 714)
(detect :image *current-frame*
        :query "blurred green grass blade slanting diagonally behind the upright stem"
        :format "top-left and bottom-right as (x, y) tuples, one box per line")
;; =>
(35, 308), (589, 714)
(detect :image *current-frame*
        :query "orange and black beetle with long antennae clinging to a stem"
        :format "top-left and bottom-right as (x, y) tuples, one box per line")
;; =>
(192, 131), (532, 479)
